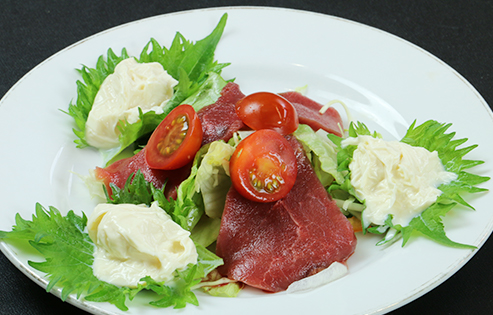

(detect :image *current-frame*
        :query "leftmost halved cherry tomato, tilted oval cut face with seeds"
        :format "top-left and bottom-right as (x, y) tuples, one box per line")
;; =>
(145, 105), (202, 170)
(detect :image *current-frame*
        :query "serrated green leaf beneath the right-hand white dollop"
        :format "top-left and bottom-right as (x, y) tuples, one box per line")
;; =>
(328, 120), (490, 249)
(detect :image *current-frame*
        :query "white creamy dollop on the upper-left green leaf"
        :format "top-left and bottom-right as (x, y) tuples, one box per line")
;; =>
(85, 58), (178, 149)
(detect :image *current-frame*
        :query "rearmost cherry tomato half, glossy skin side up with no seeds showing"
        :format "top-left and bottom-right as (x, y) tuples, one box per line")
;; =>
(235, 92), (298, 136)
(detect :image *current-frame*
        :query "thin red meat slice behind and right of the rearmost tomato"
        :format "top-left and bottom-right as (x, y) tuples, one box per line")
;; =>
(280, 92), (342, 137)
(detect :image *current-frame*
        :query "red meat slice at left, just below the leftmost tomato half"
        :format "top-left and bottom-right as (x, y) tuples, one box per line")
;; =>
(95, 148), (191, 199)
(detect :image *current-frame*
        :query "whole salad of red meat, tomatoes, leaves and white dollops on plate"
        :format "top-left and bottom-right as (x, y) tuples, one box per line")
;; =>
(0, 14), (489, 310)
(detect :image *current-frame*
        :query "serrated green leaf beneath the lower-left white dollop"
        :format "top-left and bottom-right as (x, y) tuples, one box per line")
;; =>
(0, 200), (223, 311)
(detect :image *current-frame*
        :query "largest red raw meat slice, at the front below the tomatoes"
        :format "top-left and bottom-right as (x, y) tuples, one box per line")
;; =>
(216, 136), (356, 292)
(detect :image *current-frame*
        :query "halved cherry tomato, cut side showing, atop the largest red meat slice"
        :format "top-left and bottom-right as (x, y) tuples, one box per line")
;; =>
(229, 129), (298, 202)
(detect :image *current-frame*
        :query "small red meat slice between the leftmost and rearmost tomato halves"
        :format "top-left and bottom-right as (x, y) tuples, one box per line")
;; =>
(197, 82), (245, 145)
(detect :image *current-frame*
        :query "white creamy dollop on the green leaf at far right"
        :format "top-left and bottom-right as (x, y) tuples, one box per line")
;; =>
(342, 136), (457, 226)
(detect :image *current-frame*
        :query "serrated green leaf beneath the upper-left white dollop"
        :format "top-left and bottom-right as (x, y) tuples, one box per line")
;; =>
(66, 14), (229, 161)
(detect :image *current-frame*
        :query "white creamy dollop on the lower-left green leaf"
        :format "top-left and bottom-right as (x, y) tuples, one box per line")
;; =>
(87, 203), (197, 287)
